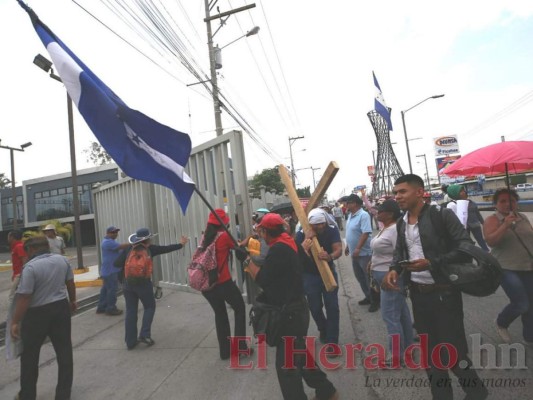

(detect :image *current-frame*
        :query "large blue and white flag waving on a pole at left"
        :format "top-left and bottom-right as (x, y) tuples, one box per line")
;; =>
(18, 0), (194, 213)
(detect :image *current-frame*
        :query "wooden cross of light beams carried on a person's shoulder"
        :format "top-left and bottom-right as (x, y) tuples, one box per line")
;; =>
(279, 161), (339, 292)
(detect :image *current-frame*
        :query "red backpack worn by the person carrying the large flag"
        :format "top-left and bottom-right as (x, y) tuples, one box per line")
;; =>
(187, 232), (222, 292)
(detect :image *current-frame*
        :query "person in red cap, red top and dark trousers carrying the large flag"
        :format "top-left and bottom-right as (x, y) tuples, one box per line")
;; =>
(200, 208), (253, 360)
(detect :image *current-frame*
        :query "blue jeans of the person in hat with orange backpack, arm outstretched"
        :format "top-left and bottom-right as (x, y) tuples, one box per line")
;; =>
(123, 280), (155, 347)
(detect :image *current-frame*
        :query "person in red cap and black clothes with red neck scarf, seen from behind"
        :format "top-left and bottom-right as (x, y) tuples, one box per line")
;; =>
(245, 213), (339, 400)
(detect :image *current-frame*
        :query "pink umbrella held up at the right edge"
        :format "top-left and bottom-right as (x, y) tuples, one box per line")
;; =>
(441, 141), (533, 176)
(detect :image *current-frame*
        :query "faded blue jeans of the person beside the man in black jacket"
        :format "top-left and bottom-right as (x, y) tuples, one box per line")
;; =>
(372, 271), (413, 358)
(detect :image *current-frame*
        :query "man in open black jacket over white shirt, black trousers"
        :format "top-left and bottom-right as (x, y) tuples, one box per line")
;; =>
(385, 174), (488, 400)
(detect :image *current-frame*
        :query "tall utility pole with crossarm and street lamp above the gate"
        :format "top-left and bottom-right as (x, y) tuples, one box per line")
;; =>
(204, 0), (259, 136)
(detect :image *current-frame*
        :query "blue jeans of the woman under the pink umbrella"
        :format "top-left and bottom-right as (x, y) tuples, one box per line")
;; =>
(497, 269), (533, 342)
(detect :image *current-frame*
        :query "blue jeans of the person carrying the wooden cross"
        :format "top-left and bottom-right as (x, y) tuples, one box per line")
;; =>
(303, 270), (340, 343)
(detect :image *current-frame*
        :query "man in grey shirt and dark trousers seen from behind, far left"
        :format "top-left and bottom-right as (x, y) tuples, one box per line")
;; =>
(11, 236), (77, 400)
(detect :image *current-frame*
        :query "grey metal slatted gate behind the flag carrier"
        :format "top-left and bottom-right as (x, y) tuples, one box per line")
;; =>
(94, 131), (253, 295)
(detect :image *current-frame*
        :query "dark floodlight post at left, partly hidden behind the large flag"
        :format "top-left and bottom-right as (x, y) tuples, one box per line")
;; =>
(33, 54), (84, 269)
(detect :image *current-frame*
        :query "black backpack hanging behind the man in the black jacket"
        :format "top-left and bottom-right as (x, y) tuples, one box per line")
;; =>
(429, 206), (503, 297)
